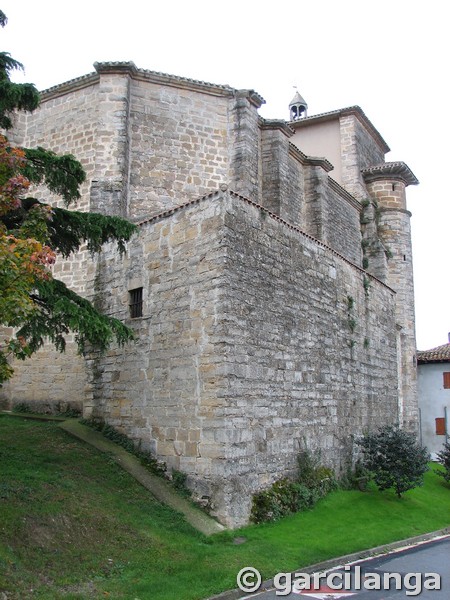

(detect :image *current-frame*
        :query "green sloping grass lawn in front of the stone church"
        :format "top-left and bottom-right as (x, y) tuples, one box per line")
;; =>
(0, 416), (450, 600)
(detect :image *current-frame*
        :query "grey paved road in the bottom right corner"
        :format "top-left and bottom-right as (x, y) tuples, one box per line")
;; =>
(243, 536), (450, 600)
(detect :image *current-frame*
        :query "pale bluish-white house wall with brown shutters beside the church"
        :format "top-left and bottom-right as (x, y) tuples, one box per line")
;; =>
(417, 363), (450, 456)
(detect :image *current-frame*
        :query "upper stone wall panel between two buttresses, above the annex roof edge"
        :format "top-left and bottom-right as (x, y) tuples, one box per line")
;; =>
(129, 80), (232, 218)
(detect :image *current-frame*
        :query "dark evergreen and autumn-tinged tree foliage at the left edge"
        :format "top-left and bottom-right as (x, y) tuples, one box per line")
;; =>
(0, 11), (135, 384)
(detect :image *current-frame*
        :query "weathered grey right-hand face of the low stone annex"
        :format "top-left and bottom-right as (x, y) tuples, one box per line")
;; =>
(215, 199), (397, 525)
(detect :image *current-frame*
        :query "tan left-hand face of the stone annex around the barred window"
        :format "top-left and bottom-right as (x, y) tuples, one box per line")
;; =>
(89, 195), (230, 486)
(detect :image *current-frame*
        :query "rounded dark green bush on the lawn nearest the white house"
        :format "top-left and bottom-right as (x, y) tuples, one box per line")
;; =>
(359, 425), (430, 498)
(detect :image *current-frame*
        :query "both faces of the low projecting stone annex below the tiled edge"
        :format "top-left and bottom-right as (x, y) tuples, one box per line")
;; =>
(84, 193), (397, 527)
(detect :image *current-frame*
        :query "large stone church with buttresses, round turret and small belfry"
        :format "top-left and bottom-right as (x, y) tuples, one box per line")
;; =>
(0, 62), (418, 527)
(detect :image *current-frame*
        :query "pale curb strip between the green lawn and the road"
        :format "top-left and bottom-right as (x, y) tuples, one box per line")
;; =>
(206, 527), (450, 600)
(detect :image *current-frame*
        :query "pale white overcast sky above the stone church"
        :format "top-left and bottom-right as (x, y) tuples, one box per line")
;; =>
(0, 0), (450, 350)
